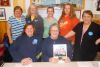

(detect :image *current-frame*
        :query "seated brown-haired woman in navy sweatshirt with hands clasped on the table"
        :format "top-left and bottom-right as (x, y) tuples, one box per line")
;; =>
(10, 23), (40, 64)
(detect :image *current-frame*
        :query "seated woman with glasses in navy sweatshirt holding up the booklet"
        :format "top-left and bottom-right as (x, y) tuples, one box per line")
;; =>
(42, 24), (72, 62)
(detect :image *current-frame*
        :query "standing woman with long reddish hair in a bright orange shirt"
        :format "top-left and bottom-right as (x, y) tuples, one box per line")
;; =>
(58, 3), (79, 44)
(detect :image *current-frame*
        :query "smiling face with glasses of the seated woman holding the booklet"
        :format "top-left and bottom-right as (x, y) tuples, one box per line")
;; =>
(50, 25), (59, 39)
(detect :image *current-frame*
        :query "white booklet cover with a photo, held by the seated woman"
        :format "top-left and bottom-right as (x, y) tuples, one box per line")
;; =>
(53, 44), (67, 60)
